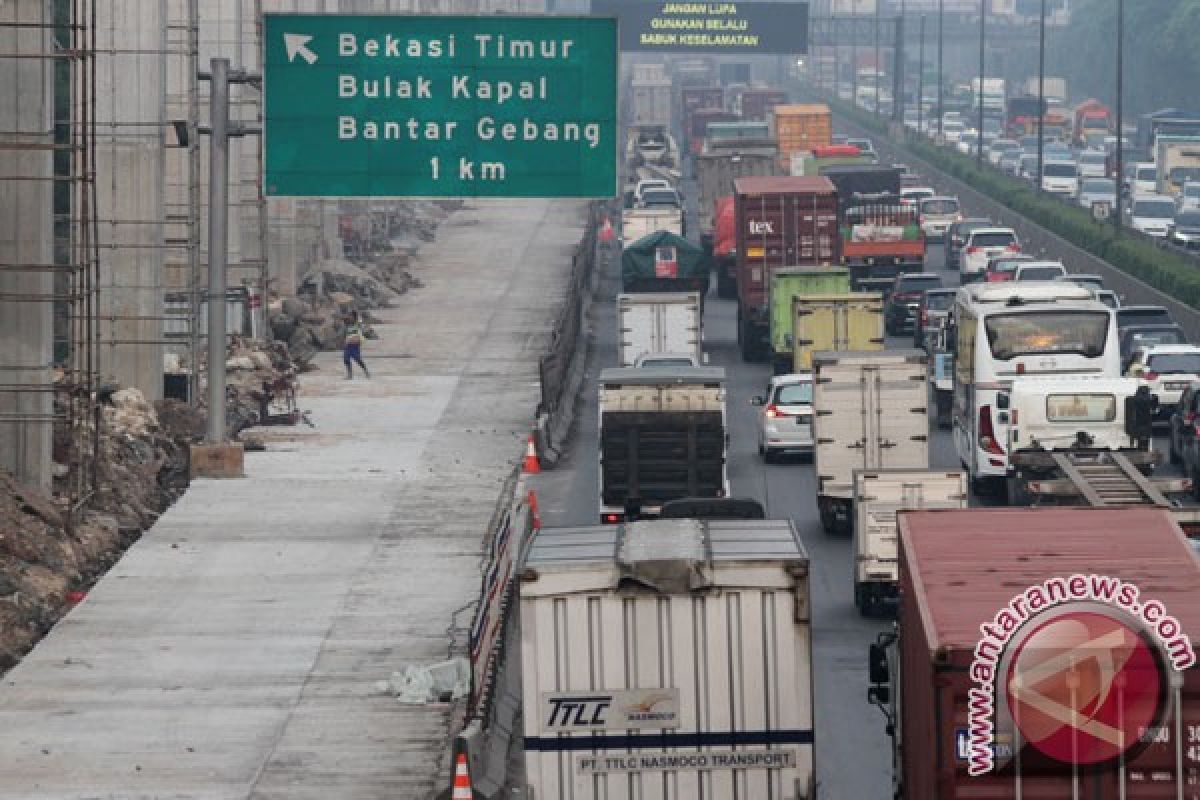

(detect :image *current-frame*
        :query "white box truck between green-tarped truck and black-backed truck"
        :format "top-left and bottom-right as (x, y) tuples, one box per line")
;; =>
(617, 291), (704, 367)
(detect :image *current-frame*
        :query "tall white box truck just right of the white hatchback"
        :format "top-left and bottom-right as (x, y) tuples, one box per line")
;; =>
(812, 350), (929, 533)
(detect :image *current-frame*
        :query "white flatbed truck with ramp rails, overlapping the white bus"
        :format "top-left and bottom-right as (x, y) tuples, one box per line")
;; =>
(996, 375), (1192, 509)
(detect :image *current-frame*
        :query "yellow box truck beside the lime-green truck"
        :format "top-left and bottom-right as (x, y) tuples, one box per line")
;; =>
(790, 291), (884, 372)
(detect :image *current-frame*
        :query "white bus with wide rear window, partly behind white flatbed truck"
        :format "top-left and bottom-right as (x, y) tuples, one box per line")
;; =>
(948, 281), (1121, 493)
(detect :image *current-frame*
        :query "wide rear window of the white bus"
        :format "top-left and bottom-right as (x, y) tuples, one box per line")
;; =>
(984, 311), (1109, 361)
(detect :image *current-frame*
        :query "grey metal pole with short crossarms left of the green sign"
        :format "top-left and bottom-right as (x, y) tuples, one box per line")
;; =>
(192, 59), (260, 445)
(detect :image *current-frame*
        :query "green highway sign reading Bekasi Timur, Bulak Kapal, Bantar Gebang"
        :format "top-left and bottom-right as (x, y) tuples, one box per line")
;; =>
(263, 14), (617, 198)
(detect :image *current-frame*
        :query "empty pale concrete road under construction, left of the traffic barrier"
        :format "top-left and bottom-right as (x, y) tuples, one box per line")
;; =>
(0, 200), (586, 800)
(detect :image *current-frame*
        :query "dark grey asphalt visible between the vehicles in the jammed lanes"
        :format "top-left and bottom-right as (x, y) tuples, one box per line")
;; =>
(538, 133), (1180, 800)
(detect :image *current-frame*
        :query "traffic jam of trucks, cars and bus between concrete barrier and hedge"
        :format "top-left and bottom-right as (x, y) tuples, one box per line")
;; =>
(520, 61), (1200, 800)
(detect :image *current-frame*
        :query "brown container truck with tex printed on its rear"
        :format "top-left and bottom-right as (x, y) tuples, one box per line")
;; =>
(733, 175), (841, 361)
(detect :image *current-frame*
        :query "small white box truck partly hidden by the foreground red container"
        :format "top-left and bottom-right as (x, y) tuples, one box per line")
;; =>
(853, 468), (970, 616)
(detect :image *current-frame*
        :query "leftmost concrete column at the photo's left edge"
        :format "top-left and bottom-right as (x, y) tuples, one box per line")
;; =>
(0, 0), (55, 487)
